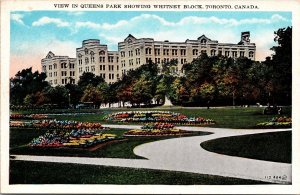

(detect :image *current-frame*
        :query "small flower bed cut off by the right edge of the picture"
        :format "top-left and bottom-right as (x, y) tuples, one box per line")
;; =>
(256, 116), (292, 128)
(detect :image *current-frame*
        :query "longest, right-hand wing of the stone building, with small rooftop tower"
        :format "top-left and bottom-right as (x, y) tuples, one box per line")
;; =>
(118, 32), (256, 75)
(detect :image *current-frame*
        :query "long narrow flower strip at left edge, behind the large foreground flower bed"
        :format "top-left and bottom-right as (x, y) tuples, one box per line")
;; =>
(10, 120), (104, 130)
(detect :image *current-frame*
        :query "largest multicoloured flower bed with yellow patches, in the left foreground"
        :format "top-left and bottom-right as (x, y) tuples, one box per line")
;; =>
(28, 129), (117, 148)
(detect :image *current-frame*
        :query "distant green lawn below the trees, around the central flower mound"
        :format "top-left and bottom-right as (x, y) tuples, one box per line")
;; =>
(11, 107), (291, 129)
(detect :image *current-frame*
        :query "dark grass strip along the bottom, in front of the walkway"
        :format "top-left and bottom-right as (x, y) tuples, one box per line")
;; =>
(9, 161), (265, 185)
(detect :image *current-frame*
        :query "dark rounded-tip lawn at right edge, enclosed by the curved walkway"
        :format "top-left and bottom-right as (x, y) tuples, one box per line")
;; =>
(201, 131), (292, 163)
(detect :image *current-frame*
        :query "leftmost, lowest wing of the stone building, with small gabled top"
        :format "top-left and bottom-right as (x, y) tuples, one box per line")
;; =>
(42, 51), (77, 86)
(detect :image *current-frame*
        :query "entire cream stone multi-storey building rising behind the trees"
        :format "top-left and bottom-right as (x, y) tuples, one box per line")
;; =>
(42, 32), (256, 85)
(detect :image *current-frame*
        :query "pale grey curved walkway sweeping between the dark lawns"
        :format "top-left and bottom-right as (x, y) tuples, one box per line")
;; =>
(11, 125), (292, 184)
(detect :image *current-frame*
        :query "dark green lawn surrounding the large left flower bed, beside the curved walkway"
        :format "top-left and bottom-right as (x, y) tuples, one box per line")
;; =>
(10, 128), (210, 158)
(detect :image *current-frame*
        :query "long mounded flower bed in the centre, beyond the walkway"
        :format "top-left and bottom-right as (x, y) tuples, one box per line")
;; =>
(105, 111), (215, 125)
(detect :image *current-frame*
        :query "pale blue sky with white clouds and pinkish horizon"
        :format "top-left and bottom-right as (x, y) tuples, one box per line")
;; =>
(10, 11), (292, 77)
